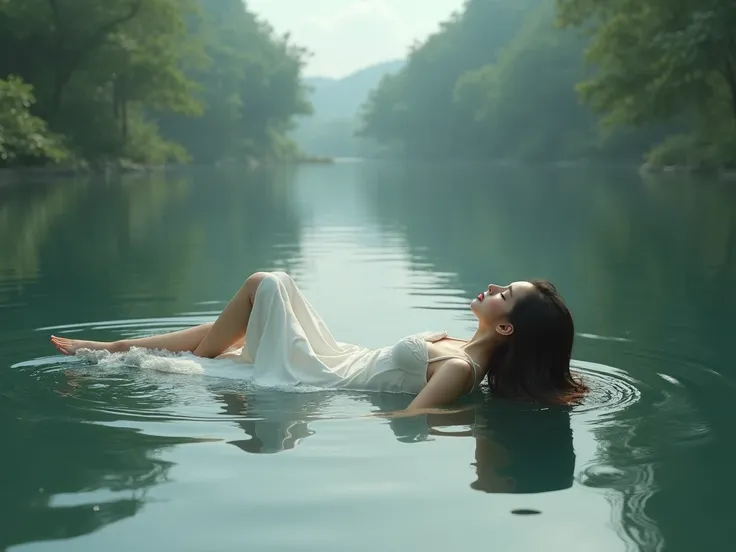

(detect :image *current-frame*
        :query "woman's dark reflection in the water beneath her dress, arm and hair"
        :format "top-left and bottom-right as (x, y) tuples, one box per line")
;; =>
(219, 393), (575, 493)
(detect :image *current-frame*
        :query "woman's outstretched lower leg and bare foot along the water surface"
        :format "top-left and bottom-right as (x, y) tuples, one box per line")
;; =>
(51, 322), (213, 355)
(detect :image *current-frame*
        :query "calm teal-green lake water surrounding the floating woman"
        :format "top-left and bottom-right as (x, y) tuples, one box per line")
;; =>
(0, 163), (736, 552)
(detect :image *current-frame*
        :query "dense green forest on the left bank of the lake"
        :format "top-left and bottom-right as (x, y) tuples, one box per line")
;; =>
(0, 0), (311, 166)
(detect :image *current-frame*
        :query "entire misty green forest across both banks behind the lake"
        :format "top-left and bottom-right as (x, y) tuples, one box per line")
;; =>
(0, 0), (736, 169)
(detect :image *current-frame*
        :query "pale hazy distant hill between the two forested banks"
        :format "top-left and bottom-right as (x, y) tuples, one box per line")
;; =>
(304, 60), (405, 120)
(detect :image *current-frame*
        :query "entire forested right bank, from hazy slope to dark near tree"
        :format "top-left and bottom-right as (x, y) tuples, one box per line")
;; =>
(360, 0), (736, 168)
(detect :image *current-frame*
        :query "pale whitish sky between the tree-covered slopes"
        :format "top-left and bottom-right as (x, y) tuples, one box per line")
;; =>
(246, 0), (464, 77)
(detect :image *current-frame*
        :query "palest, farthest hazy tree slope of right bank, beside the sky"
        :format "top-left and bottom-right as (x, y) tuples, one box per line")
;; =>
(360, 0), (541, 157)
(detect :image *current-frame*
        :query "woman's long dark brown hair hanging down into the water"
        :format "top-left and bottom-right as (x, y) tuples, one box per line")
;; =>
(488, 280), (587, 404)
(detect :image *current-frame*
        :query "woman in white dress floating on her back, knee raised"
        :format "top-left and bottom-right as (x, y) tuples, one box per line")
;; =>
(51, 272), (586, 413)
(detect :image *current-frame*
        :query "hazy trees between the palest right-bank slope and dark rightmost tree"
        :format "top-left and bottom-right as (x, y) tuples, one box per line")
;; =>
(455, 2), (600, 160)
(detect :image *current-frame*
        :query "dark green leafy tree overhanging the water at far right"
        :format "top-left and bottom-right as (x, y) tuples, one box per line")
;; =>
(557, 0), (736, 166)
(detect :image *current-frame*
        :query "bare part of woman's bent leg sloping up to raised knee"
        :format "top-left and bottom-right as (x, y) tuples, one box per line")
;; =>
(194, 272), (268, 358)
